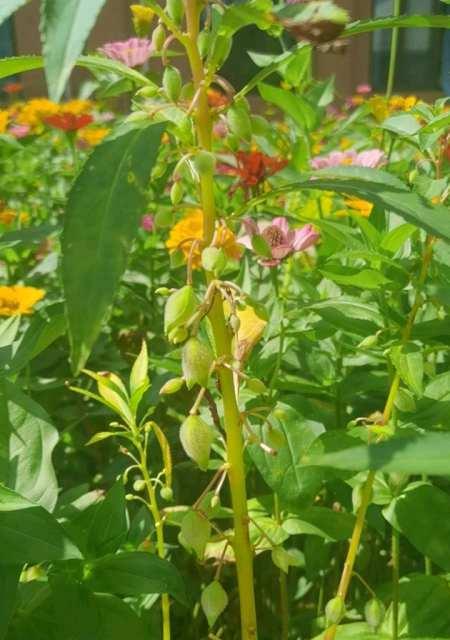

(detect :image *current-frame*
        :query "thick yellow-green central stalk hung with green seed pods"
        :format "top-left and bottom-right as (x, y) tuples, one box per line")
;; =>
(185, 0), (257, 640)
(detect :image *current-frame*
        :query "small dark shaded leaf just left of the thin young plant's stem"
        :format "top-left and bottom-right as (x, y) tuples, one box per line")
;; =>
(85, 481), (129, 558)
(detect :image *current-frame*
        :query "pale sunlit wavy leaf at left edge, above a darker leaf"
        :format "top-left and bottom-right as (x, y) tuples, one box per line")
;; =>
(5, 382), (58, 511)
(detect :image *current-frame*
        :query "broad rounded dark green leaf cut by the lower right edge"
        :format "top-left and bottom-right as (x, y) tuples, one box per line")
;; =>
(383, 484), (450, 571)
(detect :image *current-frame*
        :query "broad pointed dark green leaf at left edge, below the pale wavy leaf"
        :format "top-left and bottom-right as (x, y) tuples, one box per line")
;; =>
(0, 486), (81, 565)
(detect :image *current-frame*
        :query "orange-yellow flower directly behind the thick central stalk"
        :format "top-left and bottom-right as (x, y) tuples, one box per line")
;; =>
(166, 209), (242, 269)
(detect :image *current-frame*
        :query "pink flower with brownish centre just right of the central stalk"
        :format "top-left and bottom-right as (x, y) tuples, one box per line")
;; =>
(238, 217), (320, 267)
